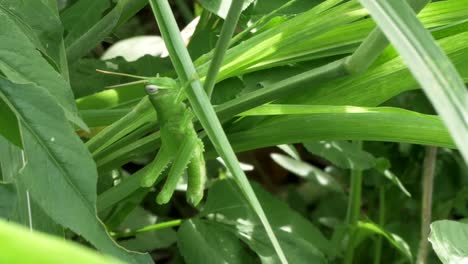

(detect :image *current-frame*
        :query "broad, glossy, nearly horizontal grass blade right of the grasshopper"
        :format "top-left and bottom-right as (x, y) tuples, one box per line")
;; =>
(221, 105), (454, 157)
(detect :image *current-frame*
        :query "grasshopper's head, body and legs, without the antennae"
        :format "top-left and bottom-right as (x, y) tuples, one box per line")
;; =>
(141, 82), (206, 205)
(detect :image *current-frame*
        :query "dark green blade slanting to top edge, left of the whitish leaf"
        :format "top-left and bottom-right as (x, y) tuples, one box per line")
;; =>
(67, 0), (147, 64)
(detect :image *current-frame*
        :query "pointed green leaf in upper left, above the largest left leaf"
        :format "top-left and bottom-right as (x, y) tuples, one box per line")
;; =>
(0, 1), (87, 129)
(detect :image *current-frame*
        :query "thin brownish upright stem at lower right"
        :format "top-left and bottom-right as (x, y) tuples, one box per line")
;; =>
(416, 147), (437, 264)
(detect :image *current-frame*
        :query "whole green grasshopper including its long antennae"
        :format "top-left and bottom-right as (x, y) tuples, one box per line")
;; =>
(98, 70), (206, 206)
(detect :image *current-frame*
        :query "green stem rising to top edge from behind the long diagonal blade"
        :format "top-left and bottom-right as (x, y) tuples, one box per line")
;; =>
(204, 1), (244, 98)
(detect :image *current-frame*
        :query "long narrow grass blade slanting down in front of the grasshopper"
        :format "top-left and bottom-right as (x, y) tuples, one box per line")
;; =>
(150, 0), (288, 263)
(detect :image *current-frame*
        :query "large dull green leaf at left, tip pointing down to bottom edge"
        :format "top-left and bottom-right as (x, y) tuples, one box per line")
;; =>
(0, 79), (151, 263)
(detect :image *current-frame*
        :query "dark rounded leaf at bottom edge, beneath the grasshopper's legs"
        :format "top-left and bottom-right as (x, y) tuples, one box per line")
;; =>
(177, 219), (256, 264)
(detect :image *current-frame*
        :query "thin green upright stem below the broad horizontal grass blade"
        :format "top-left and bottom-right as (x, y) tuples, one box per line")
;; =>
(344, 141), (362, 264)
